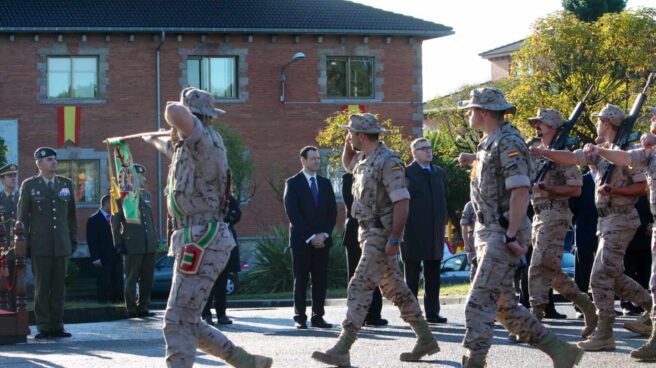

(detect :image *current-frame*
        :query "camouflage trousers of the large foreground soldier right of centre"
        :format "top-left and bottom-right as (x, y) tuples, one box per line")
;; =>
(463, 218), (547, 360)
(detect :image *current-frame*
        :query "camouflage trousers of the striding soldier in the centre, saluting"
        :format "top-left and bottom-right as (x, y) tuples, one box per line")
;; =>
(342, 229), (424, 332)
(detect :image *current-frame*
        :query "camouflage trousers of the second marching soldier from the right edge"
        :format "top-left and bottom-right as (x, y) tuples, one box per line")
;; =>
(590, 209), (651, 318)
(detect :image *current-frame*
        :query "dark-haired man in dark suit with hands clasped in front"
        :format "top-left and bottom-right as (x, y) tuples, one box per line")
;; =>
(284, 146), (337, 329)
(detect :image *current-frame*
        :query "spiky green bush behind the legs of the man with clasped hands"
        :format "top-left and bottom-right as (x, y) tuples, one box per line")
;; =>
(240, 226), (347, 293)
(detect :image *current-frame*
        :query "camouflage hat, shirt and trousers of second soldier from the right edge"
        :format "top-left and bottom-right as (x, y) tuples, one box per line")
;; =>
(574, 105), (651, 319)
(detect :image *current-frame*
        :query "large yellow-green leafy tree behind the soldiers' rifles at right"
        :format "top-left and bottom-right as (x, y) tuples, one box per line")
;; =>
(506, 8), (656, 144)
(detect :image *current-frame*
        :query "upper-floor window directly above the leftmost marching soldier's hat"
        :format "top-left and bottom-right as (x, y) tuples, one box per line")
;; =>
(187, 56), (238, 99)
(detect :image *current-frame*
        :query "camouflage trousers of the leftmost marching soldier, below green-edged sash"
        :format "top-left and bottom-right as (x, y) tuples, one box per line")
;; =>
(164, 223), (235, 368)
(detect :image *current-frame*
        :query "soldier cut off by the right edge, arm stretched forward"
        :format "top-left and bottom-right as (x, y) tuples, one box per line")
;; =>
(584, 107), (656, 361)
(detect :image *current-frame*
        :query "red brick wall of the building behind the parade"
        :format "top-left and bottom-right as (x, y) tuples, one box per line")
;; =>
(0, 34), (422, 240)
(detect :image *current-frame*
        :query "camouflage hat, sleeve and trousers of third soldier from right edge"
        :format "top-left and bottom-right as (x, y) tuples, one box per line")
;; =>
(528, 109), (583, 307)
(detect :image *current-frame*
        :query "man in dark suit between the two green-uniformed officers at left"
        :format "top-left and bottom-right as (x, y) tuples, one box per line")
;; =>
(87, 195), (123, 303)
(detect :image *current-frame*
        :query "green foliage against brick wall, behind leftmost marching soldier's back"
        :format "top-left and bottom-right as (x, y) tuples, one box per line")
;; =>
(212, 124), (254, 198)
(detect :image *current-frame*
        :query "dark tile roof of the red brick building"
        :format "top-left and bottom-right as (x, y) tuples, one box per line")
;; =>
(0, 0), (453, 38)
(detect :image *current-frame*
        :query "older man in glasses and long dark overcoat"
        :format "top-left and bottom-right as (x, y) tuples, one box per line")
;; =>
(401, 138), (447, 323)
